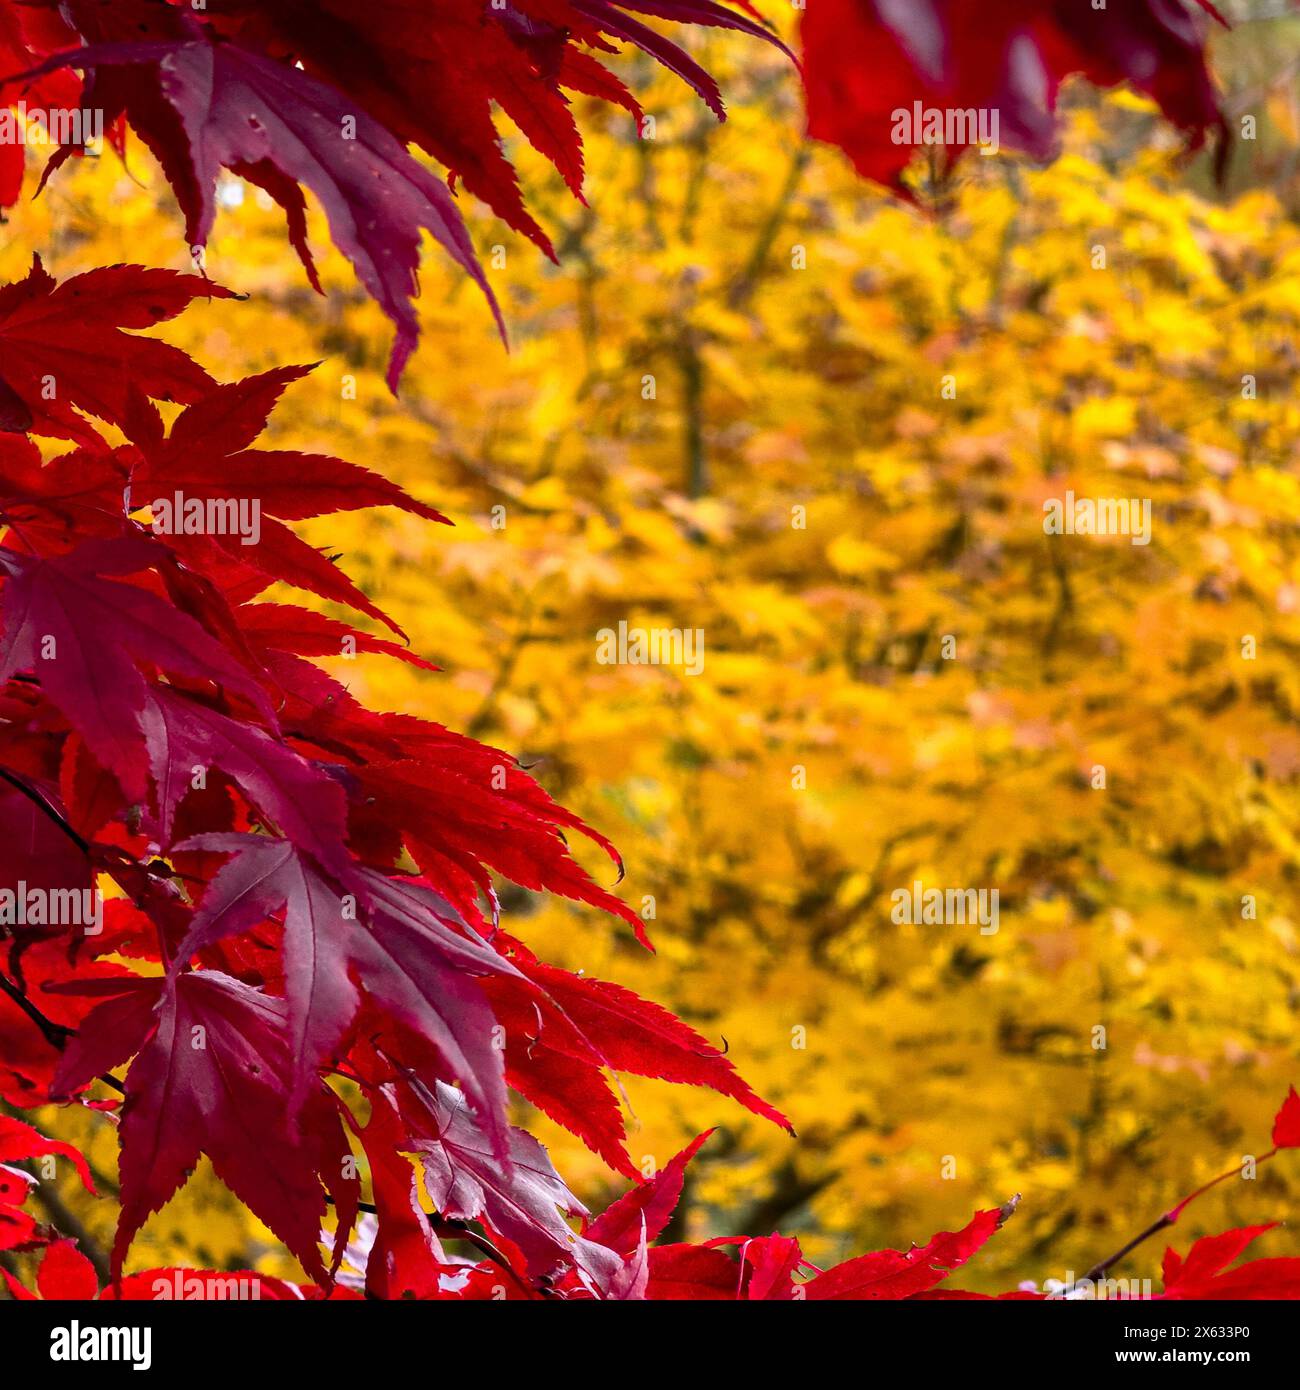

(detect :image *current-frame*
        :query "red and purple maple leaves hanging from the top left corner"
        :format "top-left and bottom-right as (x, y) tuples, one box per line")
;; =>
(0, 0), (776, 386)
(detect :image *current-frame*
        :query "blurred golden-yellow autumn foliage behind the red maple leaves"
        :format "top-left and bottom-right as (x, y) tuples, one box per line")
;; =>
(0, 4), (1300, 1290)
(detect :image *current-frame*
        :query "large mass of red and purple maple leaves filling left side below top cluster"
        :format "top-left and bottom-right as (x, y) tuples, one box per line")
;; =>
(0, 261), (787, 1293)
